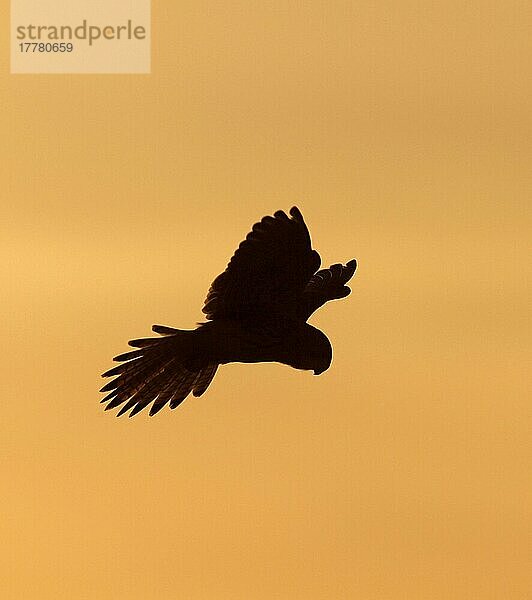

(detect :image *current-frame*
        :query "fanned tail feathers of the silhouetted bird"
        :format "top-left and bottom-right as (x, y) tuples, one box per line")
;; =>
(100, 325), (218, 417)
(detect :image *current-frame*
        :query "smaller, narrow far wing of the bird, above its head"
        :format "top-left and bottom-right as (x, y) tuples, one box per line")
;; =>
(299, 259), (357, 321)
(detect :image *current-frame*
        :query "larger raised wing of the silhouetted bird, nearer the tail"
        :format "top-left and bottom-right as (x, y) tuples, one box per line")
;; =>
(203, 206), (321, 320)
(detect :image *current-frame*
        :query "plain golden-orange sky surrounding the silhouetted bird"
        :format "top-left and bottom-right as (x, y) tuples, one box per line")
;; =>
(0, 0), (532, 600)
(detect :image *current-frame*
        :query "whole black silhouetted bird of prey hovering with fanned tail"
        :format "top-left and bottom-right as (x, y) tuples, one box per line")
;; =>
(101, 207), (356, 417)
